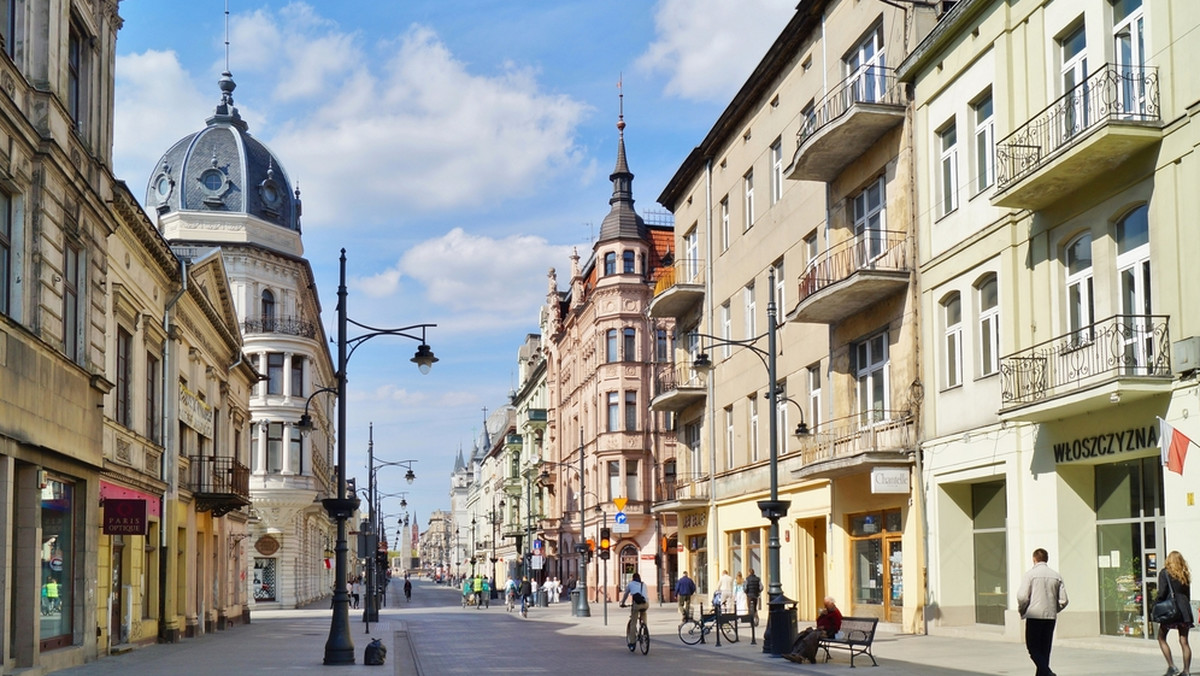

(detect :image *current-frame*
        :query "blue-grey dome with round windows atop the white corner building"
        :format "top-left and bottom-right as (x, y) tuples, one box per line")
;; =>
(145, 72), (300, 232)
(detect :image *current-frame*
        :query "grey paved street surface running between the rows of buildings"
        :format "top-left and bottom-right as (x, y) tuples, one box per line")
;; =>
(58, 581), (1178, 676)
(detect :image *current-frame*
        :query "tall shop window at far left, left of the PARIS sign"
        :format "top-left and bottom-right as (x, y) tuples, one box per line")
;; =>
(40, 479), (74, 650)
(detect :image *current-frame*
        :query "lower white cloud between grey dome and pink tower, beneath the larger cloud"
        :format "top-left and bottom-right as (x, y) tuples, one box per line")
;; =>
(355, 228), (570, 328)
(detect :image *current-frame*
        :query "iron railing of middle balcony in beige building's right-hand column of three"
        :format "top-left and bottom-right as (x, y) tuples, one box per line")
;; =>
(800, 231), (912, 301)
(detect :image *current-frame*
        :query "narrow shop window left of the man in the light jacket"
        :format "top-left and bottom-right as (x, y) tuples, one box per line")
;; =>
(971, 481), (1008, 626)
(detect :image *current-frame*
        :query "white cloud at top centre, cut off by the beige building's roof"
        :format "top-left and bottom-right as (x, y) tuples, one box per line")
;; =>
(637, 0), (796, 102)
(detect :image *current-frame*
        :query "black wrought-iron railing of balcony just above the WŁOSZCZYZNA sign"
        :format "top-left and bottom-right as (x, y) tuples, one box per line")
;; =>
(1000, 315), (1171, 407)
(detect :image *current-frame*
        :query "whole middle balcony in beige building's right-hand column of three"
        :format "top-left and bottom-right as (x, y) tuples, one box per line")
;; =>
(787, 231), (912, 324)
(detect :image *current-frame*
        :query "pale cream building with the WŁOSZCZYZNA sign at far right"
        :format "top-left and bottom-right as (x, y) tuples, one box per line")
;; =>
(900, 0), (1200, 641)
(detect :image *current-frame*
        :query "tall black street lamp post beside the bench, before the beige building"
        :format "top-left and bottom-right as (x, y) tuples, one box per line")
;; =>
(692, 267), (803, 657)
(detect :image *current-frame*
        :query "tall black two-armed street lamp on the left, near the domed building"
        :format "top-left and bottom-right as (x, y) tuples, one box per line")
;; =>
(298, 249), (438, 664)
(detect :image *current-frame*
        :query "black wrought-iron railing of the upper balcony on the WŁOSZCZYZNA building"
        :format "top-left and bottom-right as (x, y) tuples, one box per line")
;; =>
(996, 64), (1160, 192)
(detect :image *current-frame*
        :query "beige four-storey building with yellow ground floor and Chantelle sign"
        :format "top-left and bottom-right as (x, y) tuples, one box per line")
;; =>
(649, 0), (936, 630)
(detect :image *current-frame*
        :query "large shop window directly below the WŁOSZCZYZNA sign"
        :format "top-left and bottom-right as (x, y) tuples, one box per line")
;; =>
(1096, 456), (1164, 638)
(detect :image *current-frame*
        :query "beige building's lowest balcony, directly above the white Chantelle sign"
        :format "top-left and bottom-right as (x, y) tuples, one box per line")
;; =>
(792, 409), (917, 480)
